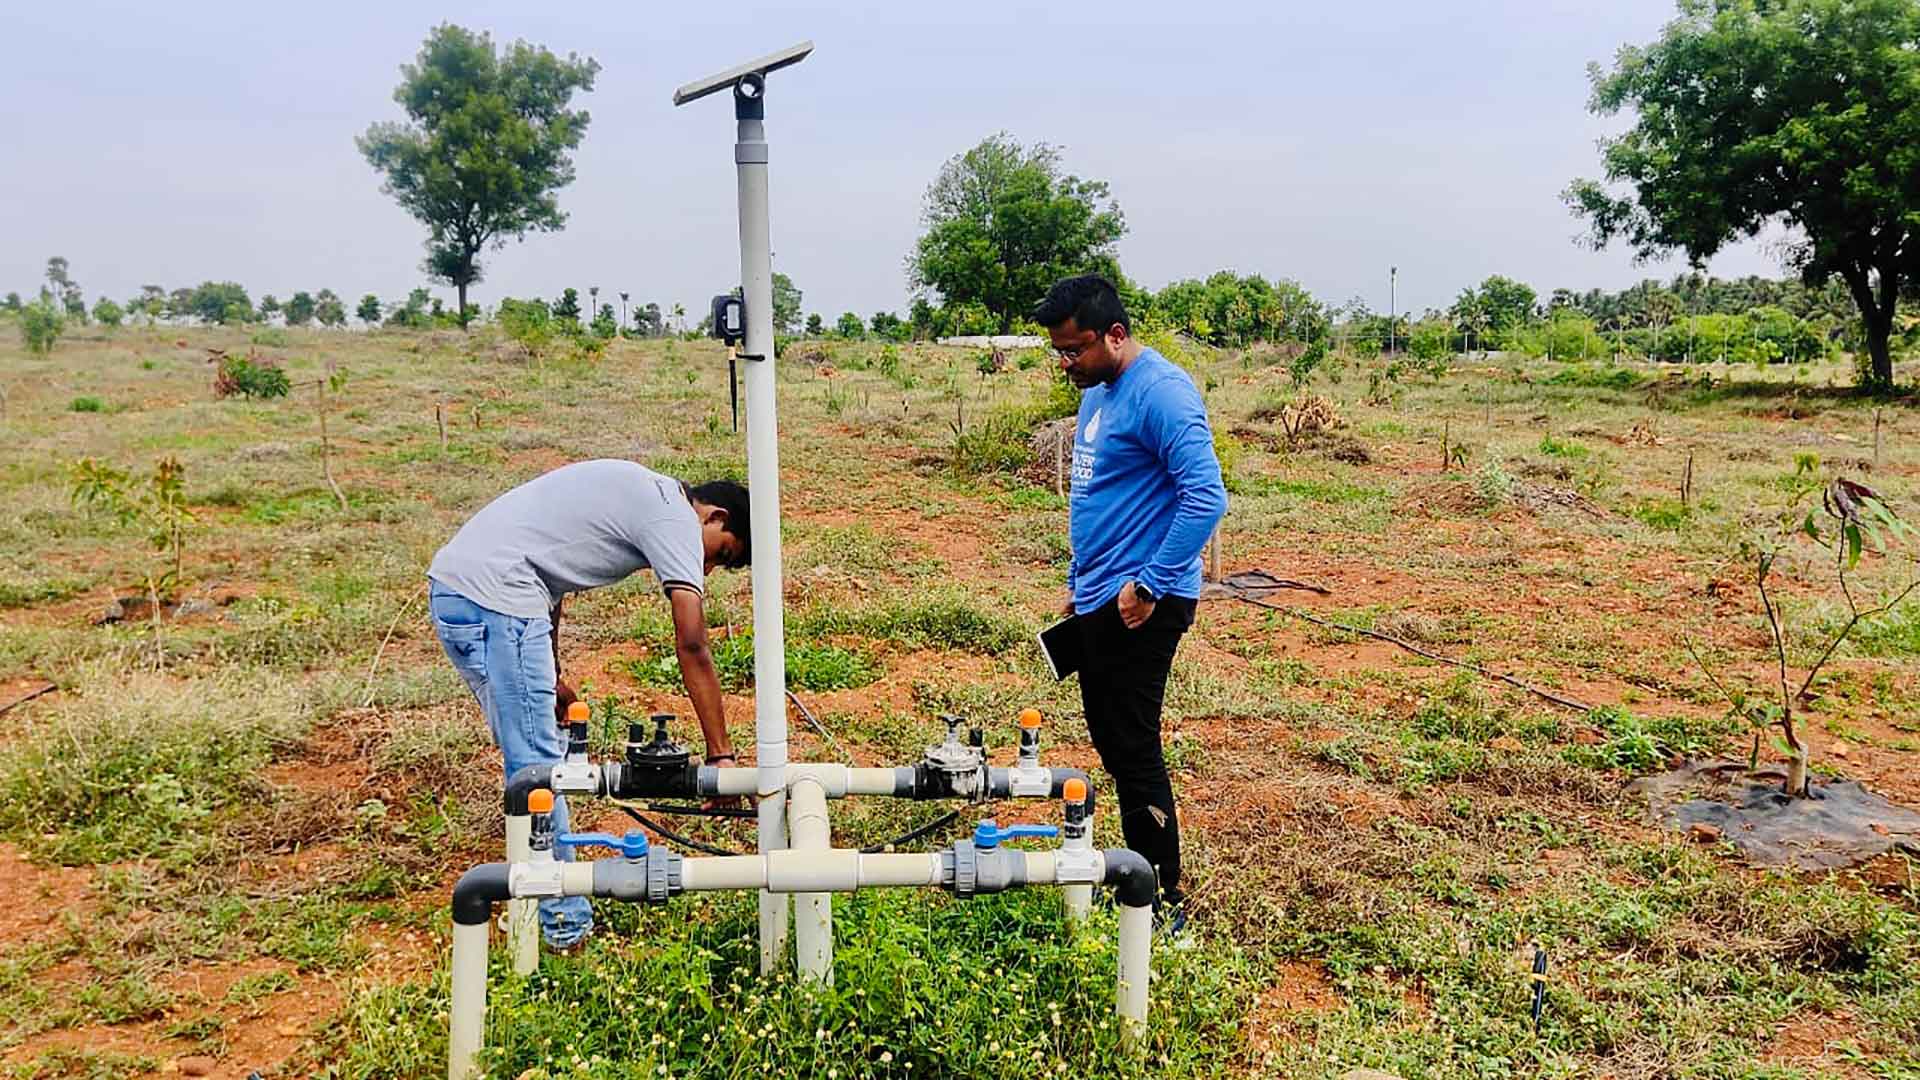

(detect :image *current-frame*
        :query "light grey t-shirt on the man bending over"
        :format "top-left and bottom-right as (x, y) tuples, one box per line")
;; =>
(426, 459), (707, 619)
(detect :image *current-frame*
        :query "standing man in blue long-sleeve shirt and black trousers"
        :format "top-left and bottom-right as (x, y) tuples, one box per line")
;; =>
(1033, 275), (1227, 932)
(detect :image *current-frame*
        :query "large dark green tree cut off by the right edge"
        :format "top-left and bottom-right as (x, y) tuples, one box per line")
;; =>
(1567, 0), (1920, 386)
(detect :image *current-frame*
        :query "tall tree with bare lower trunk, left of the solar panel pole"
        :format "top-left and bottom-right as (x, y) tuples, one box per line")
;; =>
(355, 23), (599, 325)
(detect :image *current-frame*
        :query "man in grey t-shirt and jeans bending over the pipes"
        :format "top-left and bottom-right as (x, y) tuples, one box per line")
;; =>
(426, 459), (751, 947)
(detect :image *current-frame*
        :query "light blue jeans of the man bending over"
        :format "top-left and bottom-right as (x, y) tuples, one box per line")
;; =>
(426, 580), (593, 949)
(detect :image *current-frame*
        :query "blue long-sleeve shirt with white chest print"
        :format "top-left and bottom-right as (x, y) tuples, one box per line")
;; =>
(1068, 350), (1227, 615)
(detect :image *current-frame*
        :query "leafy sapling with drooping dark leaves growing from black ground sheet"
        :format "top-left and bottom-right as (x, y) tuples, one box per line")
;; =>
(1686, 466), (1920, 798)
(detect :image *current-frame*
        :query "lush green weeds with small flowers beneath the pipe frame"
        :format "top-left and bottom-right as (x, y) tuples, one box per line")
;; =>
(311, 890), (1250, 1080)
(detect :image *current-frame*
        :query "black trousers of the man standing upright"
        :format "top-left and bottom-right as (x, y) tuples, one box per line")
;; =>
(1075, 596), (1196, 903)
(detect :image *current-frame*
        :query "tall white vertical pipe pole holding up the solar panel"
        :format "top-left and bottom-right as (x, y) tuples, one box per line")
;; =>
(733, 105), (787, 974)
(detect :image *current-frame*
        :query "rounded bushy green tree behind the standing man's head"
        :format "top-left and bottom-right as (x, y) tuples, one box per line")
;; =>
(908, 133), (1127, 334)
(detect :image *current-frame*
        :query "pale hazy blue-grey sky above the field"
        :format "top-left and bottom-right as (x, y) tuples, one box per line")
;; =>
(0, 0), (1780, 323)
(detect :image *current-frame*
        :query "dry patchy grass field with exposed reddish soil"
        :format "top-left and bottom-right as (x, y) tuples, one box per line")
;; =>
(0, 327), (1920, 1080)
